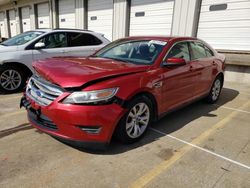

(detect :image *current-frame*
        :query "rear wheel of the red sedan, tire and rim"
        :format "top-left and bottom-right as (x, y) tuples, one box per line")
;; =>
(206, 76), (223, 104)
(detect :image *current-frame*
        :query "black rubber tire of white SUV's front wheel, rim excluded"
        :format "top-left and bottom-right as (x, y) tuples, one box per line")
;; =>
(0, 65), (27, 94)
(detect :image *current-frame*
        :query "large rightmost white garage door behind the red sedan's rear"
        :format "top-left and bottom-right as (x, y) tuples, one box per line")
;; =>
(197, 0), (250, 51)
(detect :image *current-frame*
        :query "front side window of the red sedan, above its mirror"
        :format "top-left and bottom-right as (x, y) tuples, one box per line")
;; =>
(167, 42), (190, 61)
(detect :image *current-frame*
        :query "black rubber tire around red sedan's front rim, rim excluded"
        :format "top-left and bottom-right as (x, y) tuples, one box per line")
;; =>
(115, 96), (153, 144)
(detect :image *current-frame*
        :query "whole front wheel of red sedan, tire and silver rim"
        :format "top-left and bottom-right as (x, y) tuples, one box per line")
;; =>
(115, 96), (153, 144)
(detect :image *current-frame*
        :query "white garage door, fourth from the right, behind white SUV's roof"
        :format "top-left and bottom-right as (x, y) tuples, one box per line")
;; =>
(58, 0), (76, 28)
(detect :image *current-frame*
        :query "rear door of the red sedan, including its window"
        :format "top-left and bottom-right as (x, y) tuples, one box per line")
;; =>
(189, 41), (213, 97)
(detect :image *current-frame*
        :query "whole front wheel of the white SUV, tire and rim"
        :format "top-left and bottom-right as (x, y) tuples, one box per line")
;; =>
(0, 65), (27, 94)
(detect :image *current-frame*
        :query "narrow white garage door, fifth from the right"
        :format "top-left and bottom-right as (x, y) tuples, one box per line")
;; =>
(37, 3), (50, 28)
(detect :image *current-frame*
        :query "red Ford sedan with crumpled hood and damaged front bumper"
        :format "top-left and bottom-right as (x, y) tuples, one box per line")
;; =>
(21, 37), (225, 148)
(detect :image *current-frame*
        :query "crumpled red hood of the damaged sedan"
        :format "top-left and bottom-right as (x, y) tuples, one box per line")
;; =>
(33, 57), (149, 88)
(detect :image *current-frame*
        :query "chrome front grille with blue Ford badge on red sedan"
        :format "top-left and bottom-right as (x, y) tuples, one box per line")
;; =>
(26, 76), (63, 106)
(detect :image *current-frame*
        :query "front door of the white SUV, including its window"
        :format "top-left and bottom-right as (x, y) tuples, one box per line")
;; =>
(32, 32), (68, 60)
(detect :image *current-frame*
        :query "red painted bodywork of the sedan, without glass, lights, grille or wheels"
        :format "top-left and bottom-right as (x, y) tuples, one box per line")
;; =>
(24, 37), (225, 145)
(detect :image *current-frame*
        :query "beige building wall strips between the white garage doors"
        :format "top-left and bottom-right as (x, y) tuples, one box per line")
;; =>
(0, 0), (200, 40)
